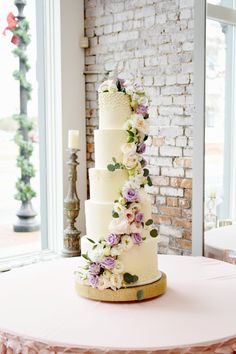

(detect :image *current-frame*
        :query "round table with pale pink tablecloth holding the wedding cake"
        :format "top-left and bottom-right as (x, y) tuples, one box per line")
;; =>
(0, 255), (236, 354)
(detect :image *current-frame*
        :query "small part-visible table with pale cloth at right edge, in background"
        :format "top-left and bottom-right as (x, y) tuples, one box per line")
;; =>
(204, 224), (236, 263)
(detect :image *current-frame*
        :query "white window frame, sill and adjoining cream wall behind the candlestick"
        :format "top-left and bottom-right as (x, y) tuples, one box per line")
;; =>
(0, 0), (87, 272)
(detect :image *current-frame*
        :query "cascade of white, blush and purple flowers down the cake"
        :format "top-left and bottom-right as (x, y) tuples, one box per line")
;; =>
(76, 78), (158, 290)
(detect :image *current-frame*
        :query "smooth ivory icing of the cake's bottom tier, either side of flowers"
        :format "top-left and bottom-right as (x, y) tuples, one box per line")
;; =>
(81, 236), (160, 285)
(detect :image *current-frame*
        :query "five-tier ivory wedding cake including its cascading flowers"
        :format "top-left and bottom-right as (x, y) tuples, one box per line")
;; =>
(76, 79), (165, 297)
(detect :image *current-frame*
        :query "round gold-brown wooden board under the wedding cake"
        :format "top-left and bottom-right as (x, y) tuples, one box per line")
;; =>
(75, 272), (167, 302)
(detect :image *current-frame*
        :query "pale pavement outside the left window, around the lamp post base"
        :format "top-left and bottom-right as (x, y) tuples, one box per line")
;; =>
(0, 224), (41, 257)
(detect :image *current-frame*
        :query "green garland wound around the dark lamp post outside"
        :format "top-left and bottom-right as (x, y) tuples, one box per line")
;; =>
(11, 19), (36, 202)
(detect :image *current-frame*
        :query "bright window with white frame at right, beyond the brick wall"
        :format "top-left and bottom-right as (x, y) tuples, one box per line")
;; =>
(205, 0), (236, 230)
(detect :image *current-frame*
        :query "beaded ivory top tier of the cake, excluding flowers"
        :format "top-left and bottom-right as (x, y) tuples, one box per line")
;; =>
(98, 92), (132, 130)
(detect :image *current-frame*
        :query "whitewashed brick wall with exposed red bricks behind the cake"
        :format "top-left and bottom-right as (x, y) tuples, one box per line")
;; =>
(85, 0), (194, 254)
